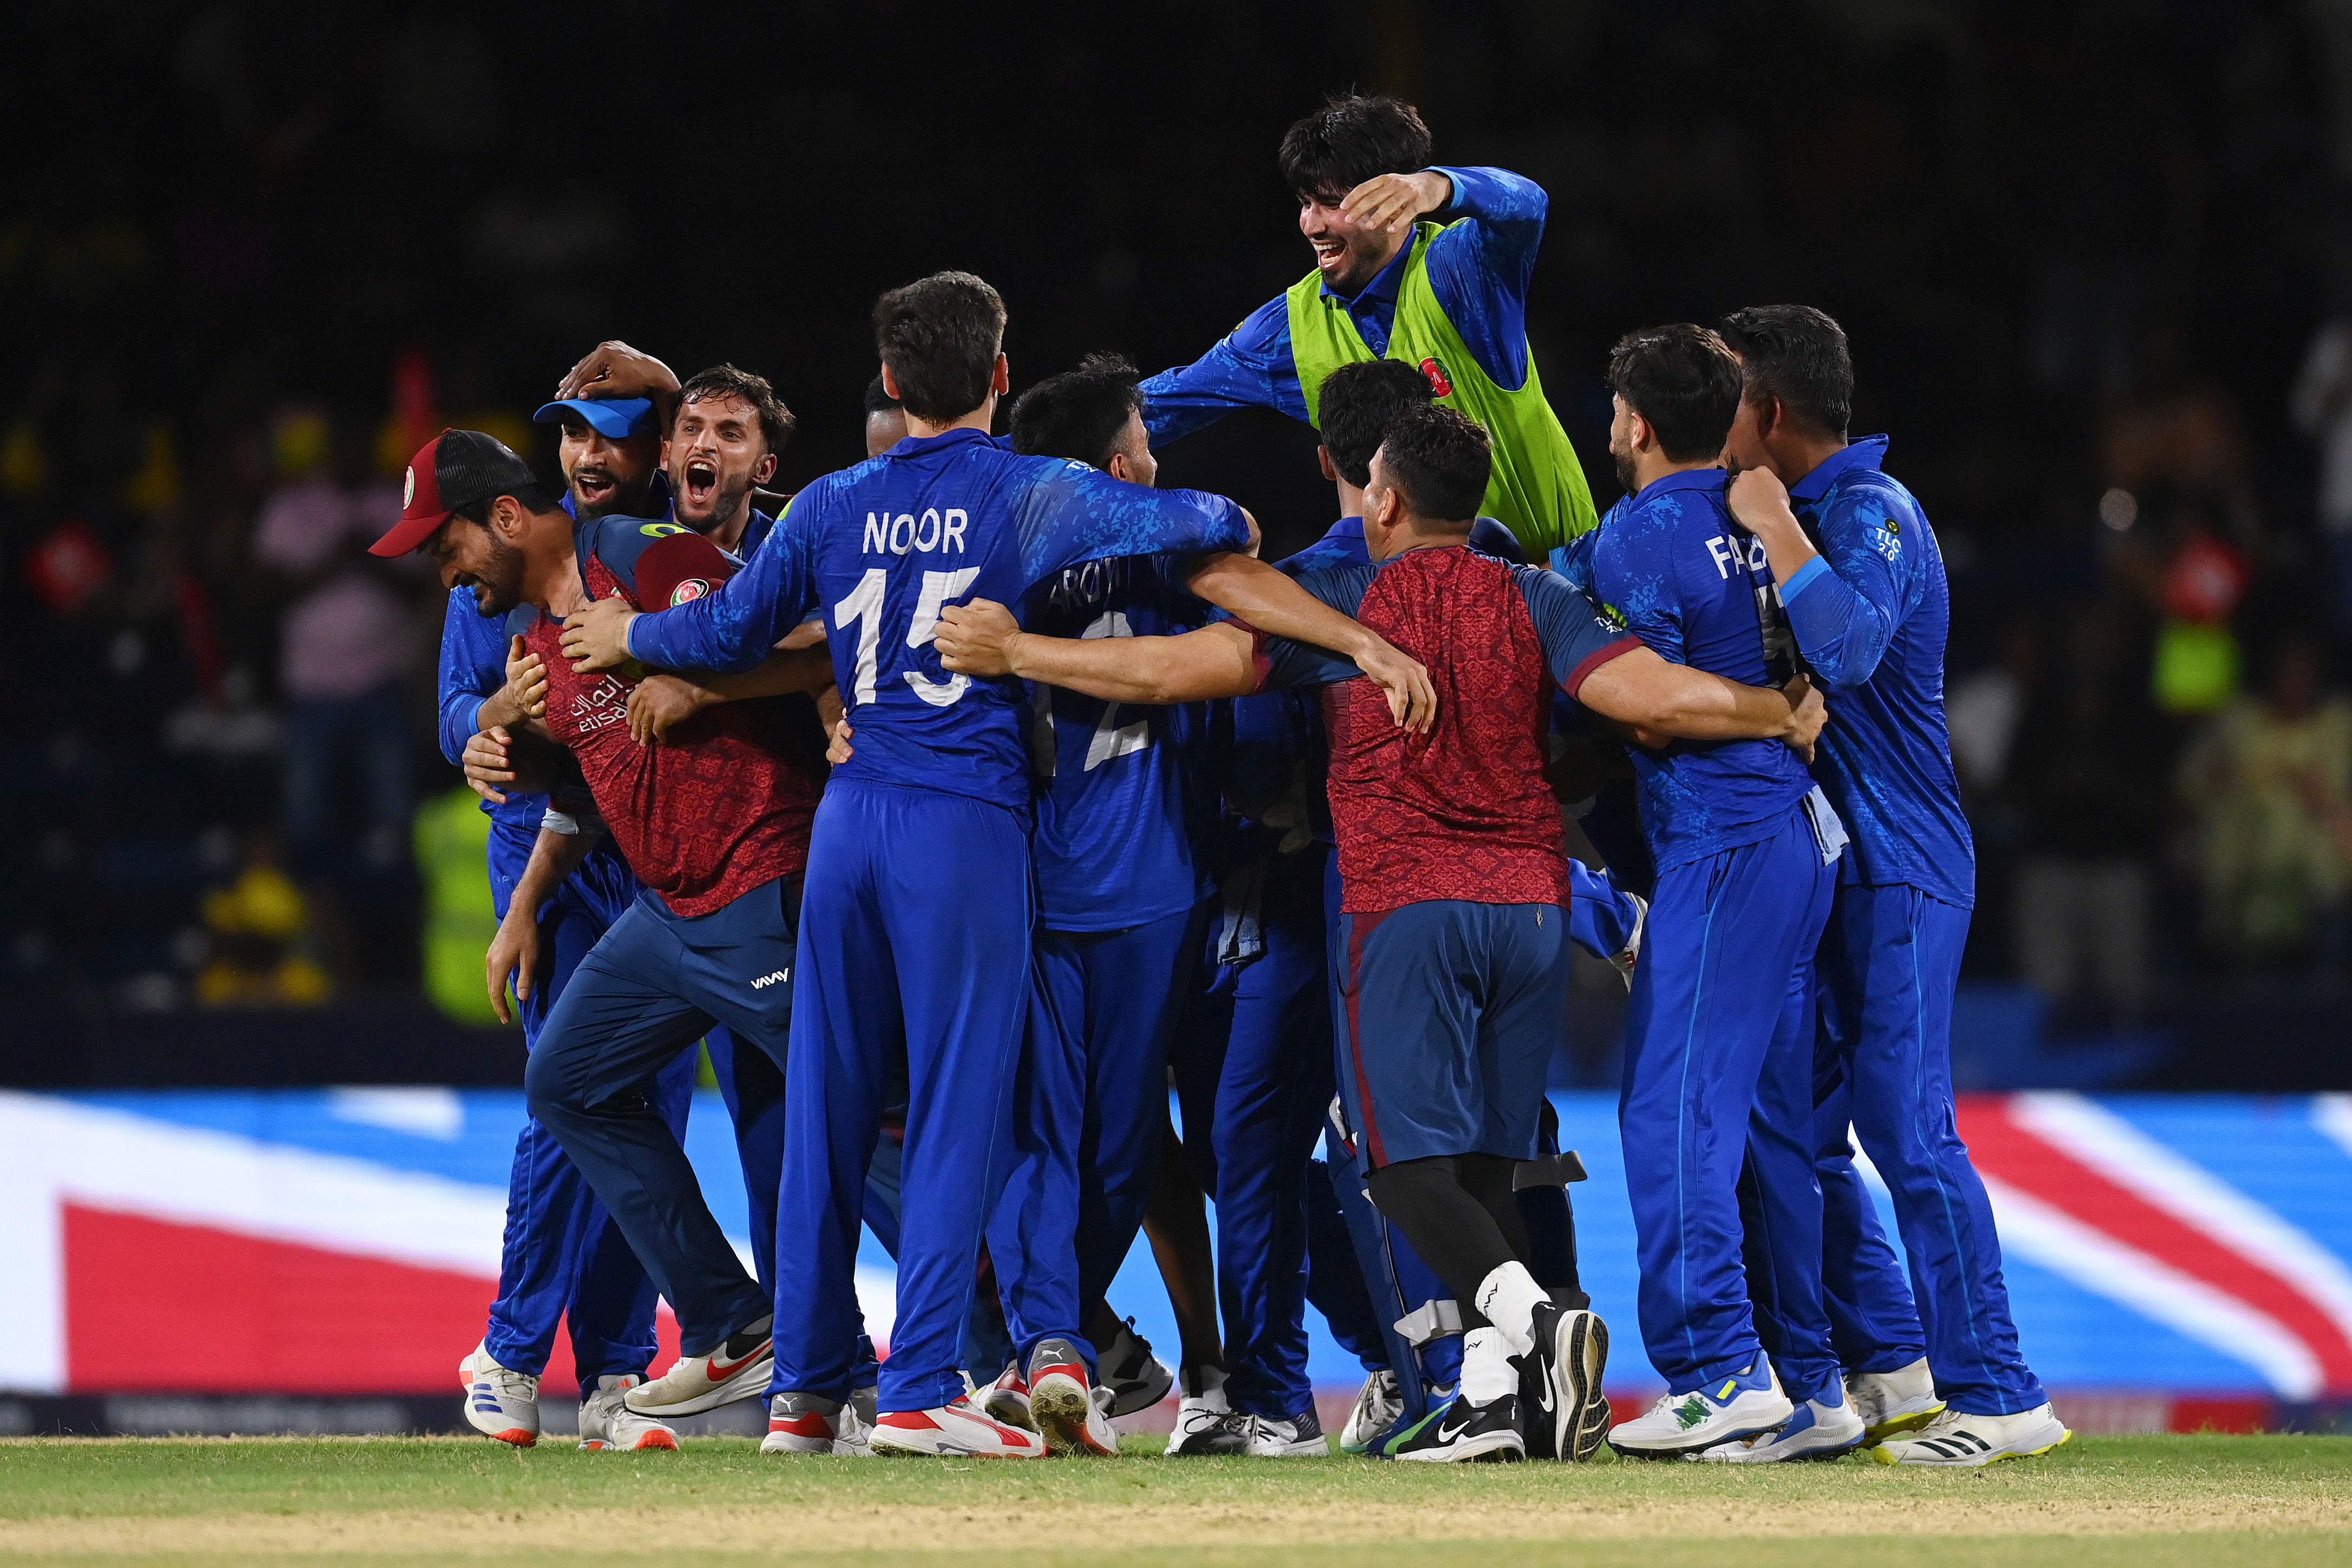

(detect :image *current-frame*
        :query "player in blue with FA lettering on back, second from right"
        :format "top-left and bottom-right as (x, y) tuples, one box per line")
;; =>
(1561, 325), (1861, 1458)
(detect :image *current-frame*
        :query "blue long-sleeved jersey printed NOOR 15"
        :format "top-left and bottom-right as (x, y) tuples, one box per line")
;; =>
(628, 430), (1249, 811)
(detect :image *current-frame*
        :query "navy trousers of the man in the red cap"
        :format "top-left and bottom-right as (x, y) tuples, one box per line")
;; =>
(522, 877), (799, 1356)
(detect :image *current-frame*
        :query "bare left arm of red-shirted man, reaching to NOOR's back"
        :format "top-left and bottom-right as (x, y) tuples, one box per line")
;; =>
(936, 599), (1258, 703)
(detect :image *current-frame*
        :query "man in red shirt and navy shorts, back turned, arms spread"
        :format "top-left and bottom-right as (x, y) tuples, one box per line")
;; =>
(938, 409), (1823, 1460)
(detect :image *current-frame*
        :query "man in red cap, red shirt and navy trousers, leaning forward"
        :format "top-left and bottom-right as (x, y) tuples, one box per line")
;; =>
(372, 430), (854, 1448)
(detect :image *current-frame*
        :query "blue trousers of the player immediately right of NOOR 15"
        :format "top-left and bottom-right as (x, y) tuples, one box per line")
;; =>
(988, 905), (1206, 1361)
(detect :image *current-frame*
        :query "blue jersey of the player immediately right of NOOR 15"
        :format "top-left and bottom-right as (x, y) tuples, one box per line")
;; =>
(1019, 555), (1216, 931)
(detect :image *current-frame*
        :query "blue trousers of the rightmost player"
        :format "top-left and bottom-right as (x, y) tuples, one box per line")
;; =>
(1816, 884), (2048, 1415)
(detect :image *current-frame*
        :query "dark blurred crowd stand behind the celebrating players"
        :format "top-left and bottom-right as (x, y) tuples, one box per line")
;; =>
(0, 0), (2352, 1089)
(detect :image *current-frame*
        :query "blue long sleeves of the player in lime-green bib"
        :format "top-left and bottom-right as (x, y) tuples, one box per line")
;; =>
(1143, 167), (1550, 447)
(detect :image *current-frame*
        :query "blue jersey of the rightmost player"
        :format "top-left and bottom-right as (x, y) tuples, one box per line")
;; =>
(1781, 435), (1976, 910)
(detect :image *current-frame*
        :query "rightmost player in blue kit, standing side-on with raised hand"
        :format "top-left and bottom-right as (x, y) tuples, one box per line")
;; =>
(1722, 306), (2067, 1465)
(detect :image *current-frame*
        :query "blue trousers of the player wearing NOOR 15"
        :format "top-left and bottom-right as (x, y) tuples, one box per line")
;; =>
(776, 778), (1035, 1411)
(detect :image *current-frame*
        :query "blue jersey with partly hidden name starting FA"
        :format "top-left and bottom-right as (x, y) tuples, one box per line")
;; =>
(1590, 468), (1814, 872)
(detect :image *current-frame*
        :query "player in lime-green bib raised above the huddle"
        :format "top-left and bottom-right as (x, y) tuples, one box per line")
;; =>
(1143, 94), (1592, 559)
